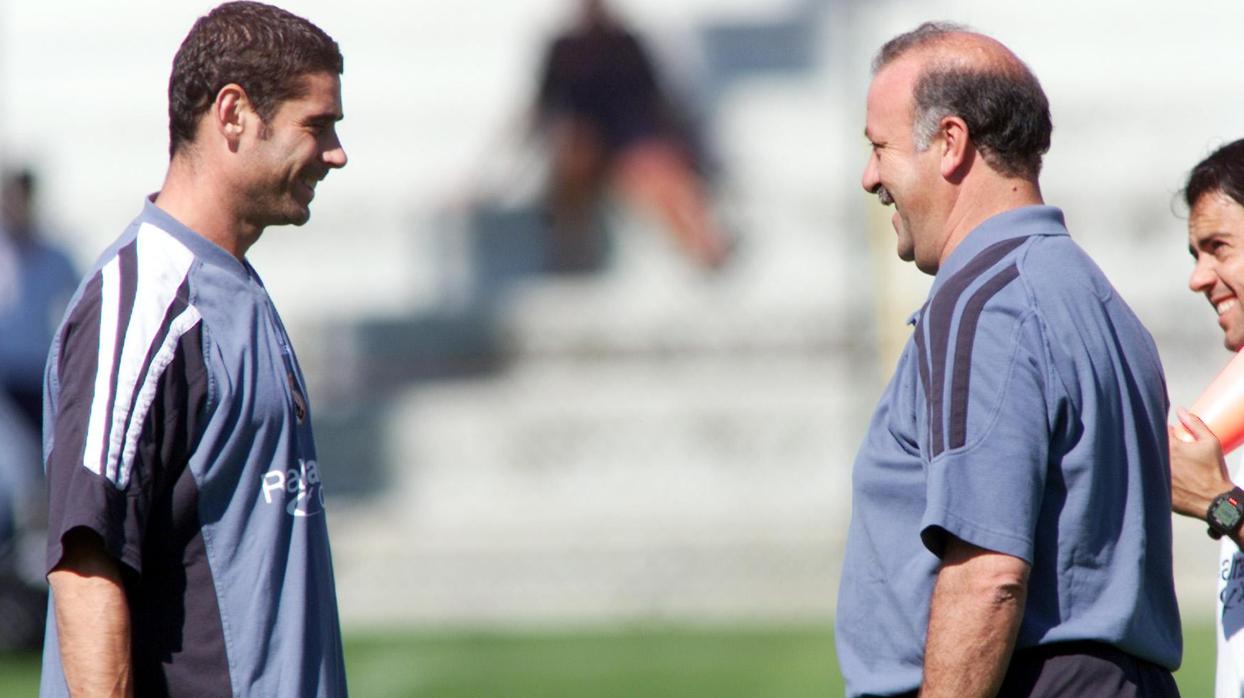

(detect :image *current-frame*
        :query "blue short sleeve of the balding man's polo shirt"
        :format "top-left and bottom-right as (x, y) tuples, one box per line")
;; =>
(921, 304), (1050, 562)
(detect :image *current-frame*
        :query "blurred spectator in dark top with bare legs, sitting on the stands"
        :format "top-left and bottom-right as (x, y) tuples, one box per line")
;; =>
(536, 0), (729, 270)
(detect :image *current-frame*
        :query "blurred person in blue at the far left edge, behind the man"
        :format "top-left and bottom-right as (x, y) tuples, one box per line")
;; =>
(0, 169), (78, 651)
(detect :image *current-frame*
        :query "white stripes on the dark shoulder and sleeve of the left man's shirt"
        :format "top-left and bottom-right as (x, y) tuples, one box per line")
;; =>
(83, 223), (198, 489)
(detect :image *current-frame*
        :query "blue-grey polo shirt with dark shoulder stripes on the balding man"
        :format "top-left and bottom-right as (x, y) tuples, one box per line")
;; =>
(836, 207), (1181, 696)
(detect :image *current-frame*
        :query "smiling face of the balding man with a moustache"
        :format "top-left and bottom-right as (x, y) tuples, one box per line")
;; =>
(860, 57), (945, 274)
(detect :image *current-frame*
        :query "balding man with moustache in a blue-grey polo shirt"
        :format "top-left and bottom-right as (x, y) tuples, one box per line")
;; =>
(837, 24), (1181, 698)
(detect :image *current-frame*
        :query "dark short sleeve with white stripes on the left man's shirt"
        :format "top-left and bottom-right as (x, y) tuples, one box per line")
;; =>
(45, 276), (207, 574)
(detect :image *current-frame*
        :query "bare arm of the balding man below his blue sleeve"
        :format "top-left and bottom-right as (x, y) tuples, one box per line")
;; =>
(921, 542), (1028, 698)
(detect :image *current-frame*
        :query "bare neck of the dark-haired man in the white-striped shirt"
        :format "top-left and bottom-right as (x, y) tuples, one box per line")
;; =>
(154, 153), (264, 261)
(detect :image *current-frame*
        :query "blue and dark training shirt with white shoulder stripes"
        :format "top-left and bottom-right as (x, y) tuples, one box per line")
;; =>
(41, 202), (346, 697)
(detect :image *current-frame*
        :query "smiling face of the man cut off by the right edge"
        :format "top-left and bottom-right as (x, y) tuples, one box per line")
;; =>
(1188, 190), (1244, 351)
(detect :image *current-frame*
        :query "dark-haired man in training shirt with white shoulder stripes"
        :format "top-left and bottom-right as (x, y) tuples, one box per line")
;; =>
(41, 2), (346, 697)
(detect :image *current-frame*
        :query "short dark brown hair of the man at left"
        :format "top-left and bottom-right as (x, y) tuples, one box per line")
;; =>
(168, 1), (343, 157)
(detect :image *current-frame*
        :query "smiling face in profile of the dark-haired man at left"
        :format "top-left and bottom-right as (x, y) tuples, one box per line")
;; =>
(239, 72), (346, 226)
